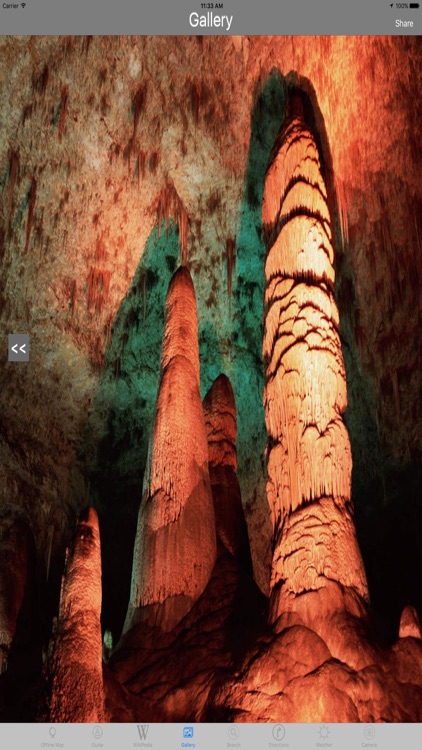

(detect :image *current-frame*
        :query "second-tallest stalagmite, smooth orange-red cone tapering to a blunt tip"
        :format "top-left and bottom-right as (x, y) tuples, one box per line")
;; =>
(125, 267), (216, 630)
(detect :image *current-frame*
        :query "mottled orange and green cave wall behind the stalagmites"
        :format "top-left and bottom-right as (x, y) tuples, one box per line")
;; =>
(0, 37), (422, 648)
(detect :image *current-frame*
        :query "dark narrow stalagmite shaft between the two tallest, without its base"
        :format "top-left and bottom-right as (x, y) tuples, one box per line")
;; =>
(204, 374), (252, 570)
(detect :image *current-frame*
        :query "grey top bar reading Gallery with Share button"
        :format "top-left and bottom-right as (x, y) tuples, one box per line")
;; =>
(0, 0), (422, 36)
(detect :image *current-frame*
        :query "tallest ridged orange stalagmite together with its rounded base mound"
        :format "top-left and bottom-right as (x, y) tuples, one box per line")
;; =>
(207, 98), (422, 722)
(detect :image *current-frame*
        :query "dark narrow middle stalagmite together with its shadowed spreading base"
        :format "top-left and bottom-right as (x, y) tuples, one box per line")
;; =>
(108, 378), (266, 721)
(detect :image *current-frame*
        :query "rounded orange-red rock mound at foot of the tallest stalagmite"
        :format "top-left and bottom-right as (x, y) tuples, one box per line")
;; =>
(216, 625), (422, 722)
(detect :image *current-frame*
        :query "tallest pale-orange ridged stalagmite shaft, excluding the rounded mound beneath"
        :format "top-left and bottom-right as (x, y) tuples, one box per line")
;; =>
(263, 96), (367, 622)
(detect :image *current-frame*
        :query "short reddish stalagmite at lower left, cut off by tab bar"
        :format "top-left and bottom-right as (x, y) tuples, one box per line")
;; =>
(48, 508), (105, 722)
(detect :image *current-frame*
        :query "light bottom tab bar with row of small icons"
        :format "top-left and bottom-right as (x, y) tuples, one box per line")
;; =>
(0, 722), (422, 750)
